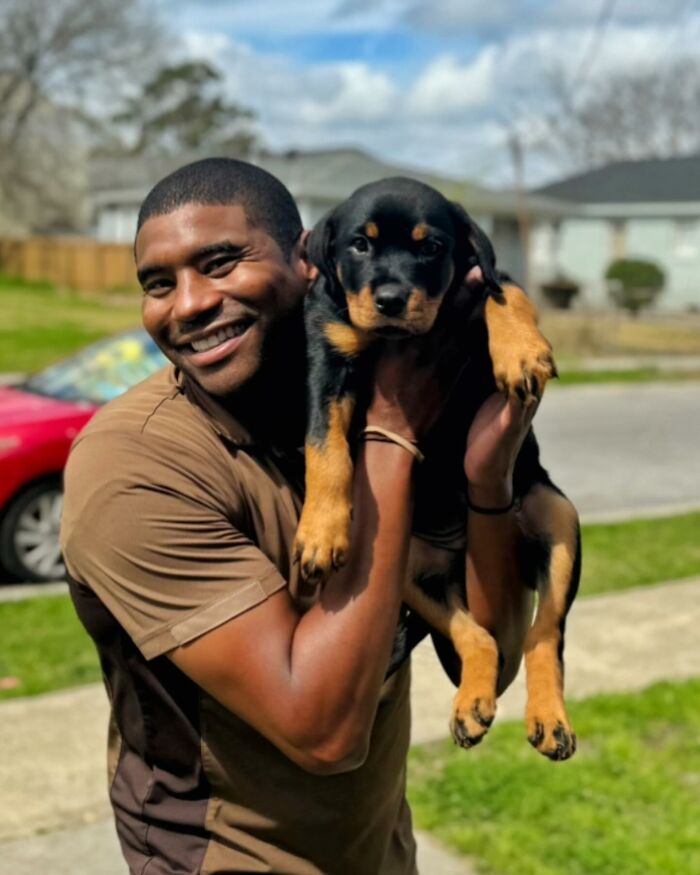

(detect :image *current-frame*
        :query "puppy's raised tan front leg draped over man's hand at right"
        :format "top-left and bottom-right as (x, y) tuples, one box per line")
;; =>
(484, 282), (557, 403)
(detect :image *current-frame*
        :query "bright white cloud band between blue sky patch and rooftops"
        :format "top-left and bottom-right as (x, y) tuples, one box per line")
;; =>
(176, 0), (700, 184)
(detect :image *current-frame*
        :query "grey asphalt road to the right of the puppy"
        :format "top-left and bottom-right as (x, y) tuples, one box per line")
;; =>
(535, 383), (700, 519)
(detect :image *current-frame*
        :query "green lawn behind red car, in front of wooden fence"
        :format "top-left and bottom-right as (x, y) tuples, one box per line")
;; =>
(0, 277), (140, 372)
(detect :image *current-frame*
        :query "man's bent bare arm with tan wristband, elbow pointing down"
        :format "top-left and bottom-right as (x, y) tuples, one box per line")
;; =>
(170, 344), (443, 773)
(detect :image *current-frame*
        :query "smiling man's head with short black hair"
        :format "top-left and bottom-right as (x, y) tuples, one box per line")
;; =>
(134, 158), (308, 396)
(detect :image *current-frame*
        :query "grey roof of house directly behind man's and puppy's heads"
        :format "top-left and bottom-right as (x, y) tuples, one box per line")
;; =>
(89, 147), (567, 216)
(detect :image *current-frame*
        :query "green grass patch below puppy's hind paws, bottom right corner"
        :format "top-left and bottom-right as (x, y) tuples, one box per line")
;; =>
(409, 680), (700, 875)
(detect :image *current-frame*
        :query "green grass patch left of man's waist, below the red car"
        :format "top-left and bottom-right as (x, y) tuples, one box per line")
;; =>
(0, 596), (101, 699)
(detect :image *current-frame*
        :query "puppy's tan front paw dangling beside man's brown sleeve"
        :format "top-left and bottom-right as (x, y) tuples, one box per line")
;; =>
(294, 505), (350, 584)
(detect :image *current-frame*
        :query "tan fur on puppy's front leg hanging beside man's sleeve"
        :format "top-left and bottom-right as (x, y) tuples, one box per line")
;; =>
(295, 397), (354, 578)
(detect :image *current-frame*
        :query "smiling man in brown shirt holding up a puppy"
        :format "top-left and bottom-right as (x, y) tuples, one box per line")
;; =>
(62, 159), (533, 875)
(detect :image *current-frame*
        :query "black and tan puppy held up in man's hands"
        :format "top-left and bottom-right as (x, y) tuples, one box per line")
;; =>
(296, 178), (580, 759)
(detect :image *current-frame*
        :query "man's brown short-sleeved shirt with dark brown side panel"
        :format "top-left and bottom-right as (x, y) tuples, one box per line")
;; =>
(62, 367), (416, 875)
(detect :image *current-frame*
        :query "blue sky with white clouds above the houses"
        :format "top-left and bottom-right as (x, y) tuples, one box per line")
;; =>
(166, 0), (700, 186)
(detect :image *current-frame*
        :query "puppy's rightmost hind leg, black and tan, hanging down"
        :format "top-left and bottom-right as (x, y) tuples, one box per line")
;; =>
(521, 484), (580, 760)
